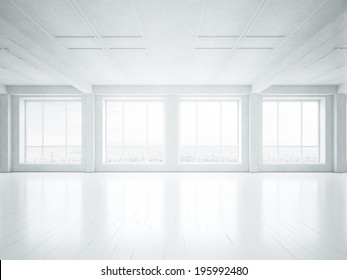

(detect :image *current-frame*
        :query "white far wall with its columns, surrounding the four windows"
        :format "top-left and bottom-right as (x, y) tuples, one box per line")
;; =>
(5, 86), (346, 172)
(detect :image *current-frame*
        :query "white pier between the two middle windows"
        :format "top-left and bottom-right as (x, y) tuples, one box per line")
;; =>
(165, 96), (179, 170)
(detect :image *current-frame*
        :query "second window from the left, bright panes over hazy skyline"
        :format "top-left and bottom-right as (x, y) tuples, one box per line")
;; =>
(104, 100), (164, 163)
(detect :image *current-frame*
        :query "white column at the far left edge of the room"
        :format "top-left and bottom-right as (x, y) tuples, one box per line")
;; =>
(0, 91), (11, 172)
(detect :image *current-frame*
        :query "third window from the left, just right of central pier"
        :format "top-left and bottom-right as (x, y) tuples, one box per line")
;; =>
(180, 100), (240, 163)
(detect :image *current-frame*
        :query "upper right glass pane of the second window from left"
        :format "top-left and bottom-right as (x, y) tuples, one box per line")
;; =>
(148, 102), (164, 146)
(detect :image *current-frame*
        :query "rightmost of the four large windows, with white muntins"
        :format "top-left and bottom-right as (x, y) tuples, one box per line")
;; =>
(263, 99), (321, 164)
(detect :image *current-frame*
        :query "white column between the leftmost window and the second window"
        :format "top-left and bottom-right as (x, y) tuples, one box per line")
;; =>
(83, 94), (95, 172)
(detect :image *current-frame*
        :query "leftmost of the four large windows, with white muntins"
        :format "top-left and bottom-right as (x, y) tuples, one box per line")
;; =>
(20, 99), (82, 164)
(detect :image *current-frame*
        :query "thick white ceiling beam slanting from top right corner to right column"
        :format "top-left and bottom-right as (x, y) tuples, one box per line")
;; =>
(252, 0), (347, 93)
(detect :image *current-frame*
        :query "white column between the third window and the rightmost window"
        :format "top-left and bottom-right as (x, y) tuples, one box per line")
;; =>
(249, 93), (260, 172)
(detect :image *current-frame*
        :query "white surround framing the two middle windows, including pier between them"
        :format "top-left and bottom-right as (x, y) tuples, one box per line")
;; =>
(95, 95), (249, 172)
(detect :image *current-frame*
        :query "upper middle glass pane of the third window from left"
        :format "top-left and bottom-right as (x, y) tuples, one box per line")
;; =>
(197, 102), (221, 147)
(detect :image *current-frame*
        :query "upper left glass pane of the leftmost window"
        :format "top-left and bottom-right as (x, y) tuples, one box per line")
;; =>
(25, 101), (42, 146)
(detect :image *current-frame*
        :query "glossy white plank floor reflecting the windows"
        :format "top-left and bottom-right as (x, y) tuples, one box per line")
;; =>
(0, 173), (347, 259)
